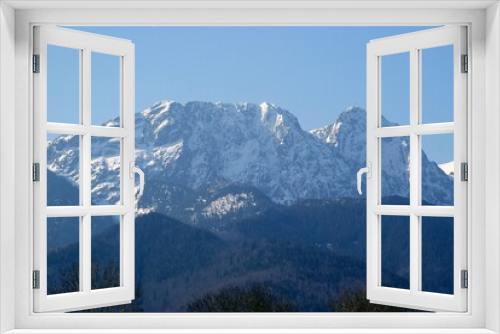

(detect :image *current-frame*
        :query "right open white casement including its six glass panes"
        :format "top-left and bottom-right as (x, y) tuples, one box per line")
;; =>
(367, 27), (467, 312)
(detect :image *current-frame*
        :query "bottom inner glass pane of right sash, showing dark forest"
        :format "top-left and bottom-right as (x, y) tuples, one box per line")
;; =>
(381, 216), (410, 289)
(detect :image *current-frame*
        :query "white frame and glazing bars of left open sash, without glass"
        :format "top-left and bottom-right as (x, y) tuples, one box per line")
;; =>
(33, 26), (135, 312)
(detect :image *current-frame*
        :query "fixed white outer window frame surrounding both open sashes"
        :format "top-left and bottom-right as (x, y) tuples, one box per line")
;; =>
(0, 1), (500, 333)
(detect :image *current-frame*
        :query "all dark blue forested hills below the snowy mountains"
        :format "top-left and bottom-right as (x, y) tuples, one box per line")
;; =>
(49, 199), (453, 312)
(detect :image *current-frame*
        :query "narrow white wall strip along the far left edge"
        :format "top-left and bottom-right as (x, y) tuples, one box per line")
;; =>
(0, 3), (15, 333)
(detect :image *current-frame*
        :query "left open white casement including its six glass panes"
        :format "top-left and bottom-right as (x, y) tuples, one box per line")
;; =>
(34, 27), (144, 312)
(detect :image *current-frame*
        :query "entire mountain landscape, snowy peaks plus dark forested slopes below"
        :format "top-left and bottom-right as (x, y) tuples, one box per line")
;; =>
(47, 102), (453, 312)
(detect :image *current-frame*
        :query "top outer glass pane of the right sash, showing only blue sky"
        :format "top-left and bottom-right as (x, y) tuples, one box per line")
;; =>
(421, 45), (454, 124)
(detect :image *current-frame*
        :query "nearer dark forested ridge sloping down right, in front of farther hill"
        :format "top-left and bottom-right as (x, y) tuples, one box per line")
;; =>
(48, 211), (414, 312)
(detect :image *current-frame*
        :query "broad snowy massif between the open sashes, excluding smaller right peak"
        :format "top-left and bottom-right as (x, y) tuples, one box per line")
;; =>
(136, 102), (354, 203)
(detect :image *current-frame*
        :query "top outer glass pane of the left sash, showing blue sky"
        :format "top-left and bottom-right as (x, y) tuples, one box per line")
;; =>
(47, 45), (80, 124)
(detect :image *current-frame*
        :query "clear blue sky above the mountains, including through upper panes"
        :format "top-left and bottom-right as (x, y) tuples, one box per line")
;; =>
(48, 27), (453, 163)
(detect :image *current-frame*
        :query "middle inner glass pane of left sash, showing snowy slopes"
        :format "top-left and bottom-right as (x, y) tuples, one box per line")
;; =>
(91, 137), (121, 205)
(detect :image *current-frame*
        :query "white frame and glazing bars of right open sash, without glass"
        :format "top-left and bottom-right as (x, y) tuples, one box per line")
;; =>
(360, 26), (470, 312)
